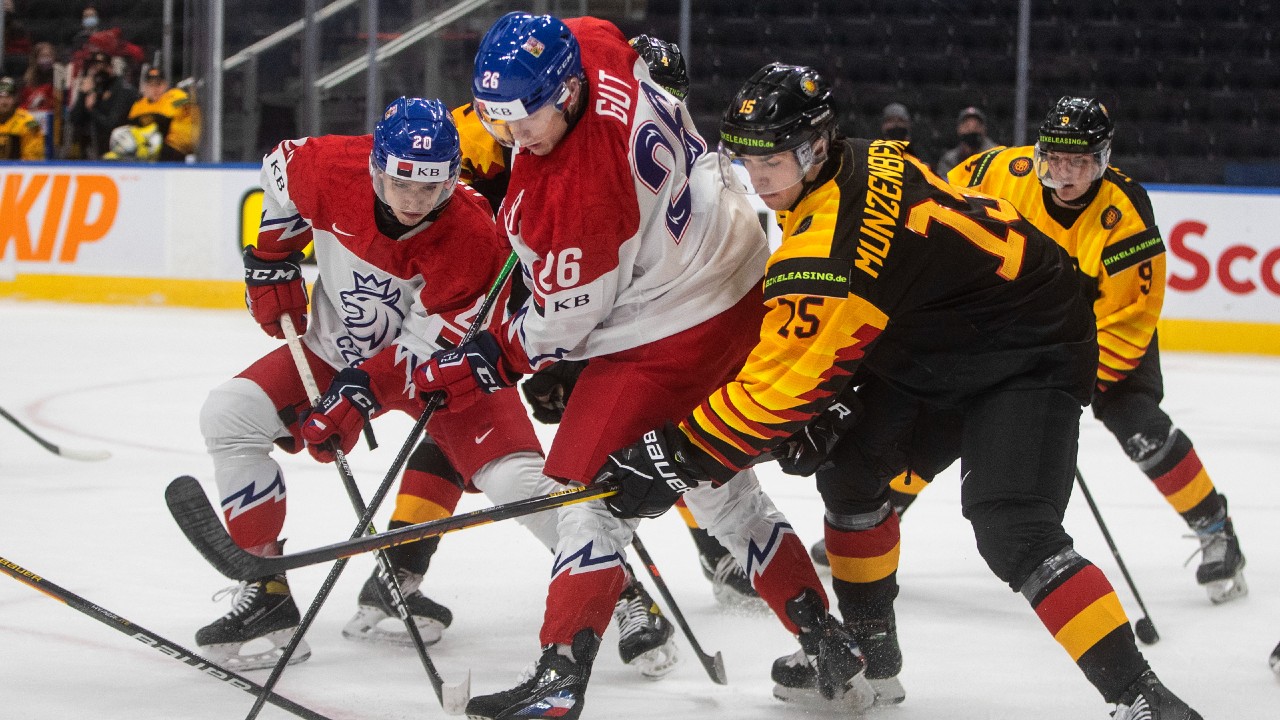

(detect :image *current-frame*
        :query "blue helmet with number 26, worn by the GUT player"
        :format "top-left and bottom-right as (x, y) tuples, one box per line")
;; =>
(471, 13), (582, 120)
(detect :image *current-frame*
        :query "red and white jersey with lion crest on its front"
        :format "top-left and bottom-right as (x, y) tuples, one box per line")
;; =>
(257, 135), (511, 398)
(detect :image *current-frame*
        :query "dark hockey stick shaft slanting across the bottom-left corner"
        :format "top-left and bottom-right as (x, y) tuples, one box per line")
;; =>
(0, 557), (330, 720)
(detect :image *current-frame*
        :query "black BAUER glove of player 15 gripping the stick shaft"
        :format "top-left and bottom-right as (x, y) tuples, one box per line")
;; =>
(595, 423), (707, 518)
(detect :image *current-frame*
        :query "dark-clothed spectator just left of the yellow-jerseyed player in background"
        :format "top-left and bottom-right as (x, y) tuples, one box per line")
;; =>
(65, 53), (138, 160)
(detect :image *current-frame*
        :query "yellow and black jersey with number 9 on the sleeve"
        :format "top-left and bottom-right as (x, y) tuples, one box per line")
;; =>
(947, 146), (1165, 387)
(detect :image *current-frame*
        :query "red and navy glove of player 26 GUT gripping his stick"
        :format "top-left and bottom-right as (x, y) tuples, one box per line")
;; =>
(413, 332), (520, 410)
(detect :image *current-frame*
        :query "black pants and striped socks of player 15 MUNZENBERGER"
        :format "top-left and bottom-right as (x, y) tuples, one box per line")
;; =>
(819, 386), (1147, 702)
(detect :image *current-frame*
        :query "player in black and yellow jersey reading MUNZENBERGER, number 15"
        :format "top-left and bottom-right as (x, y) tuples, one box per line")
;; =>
(593, 63), (1201, 720)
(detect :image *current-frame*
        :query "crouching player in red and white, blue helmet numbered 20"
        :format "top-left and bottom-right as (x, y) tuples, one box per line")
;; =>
(196, 99), (672, 669)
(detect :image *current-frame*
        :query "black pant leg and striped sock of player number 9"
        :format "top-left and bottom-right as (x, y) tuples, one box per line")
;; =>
(1093, 336), (1224, 527)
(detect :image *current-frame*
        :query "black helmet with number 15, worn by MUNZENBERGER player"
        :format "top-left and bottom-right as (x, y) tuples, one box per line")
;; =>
(721, 63), (836, 155)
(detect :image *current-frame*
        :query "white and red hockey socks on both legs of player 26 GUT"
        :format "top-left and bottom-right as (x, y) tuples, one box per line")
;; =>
(540, 470), (826, 646)
